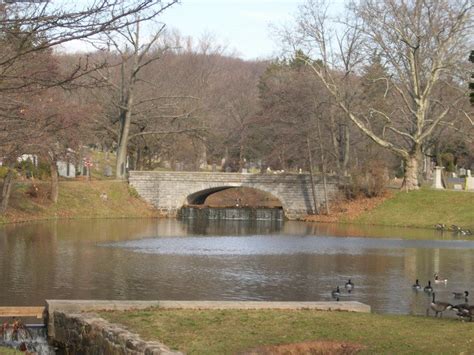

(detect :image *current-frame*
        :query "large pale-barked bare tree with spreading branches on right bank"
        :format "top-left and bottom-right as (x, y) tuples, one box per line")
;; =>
(282, 0), (473, 190)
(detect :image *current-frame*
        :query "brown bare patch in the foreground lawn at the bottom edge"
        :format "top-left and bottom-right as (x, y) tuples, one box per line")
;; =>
(242, 341), (365, 355)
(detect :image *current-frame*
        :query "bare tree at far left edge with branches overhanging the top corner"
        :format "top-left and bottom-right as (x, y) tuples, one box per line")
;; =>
(0, 0), (177, 213)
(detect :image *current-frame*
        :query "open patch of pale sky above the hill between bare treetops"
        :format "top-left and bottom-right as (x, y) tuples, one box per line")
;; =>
(161, 0), (301, 59)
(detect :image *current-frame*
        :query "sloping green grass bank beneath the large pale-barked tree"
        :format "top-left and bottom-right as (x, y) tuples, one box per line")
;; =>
(350, 189), (474, 228)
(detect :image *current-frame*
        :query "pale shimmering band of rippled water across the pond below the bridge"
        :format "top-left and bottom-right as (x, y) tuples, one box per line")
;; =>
(99, 235), (474, 256)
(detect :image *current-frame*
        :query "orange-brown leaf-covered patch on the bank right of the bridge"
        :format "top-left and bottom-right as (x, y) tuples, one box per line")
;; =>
(304, 191), (392, 223)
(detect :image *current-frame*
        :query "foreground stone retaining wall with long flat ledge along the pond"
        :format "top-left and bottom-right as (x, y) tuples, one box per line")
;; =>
(46, 300), (370, 355)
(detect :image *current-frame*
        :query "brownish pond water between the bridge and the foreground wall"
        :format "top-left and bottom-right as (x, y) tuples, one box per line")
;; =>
(0, 219), (474, 314)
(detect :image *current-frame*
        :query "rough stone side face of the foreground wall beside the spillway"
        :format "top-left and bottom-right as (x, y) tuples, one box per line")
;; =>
(53, 311), (181, 355)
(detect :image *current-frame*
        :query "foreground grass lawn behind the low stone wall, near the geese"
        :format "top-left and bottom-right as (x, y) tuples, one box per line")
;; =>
(101, 309), (474, 354)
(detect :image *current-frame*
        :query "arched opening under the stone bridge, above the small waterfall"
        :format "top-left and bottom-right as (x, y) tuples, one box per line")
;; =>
(186, 186), (283, 209)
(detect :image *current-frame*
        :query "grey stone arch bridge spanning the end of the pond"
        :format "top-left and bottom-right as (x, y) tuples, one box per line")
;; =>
(129, 171), (338, 219)
